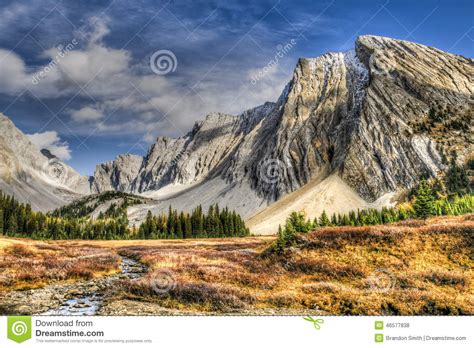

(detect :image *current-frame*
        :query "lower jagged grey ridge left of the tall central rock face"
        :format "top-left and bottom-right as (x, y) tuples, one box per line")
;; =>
(93, 103), (274, 193)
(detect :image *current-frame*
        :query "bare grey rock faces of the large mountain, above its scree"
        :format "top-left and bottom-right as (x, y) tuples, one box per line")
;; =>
(90, 35), (473, 228)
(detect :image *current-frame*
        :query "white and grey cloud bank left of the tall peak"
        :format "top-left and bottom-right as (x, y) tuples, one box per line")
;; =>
(0, 11), (289, 140)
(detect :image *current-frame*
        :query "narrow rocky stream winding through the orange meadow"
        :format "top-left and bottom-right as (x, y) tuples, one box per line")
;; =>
(41, 256), (146, 316)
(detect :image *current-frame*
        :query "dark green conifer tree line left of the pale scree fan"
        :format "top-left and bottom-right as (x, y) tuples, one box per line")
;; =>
(0, 190), (249, 240)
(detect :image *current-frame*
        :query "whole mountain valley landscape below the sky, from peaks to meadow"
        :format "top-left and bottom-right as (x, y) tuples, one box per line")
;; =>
(0, 35), (474, 315)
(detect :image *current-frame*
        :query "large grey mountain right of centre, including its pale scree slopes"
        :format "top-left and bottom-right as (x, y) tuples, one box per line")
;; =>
(93, 36), (474, 233)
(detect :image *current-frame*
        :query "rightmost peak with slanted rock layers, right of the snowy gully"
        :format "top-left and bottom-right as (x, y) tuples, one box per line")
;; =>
(340, 36), (474, 200)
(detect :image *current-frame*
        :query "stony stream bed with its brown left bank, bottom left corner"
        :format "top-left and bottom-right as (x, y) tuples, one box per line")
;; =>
(0, 256), (147, 315)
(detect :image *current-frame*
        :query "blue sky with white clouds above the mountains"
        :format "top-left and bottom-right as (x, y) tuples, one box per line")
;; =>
(0, 0), (474, 174)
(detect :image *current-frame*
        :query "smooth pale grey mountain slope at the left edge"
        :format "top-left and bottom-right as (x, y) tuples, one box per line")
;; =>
(0, 113), (90, 211)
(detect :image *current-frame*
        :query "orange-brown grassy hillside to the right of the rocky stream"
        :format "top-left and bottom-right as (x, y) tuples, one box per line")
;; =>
(114, 215), (474, 315)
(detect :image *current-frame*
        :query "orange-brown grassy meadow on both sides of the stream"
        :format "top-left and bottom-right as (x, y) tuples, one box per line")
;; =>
(0, 215), (474, 315)
